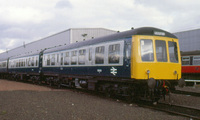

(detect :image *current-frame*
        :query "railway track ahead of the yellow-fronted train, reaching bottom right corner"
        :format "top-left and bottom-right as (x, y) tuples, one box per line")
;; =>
(137, 101), (200, 120)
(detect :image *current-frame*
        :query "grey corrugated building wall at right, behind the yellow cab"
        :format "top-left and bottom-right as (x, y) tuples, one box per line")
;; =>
(174, 29), (200, 52)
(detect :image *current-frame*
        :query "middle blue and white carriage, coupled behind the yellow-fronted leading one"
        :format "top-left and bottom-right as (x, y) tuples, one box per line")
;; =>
(8, 52), (40, 82)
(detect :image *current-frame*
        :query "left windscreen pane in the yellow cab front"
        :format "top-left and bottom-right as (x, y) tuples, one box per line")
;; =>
(140, 39), (154, 61)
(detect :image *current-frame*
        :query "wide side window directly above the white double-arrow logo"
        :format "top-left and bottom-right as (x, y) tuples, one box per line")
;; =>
(108, 44), (120, 64)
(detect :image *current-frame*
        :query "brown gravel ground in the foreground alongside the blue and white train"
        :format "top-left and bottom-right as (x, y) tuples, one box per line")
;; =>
(0, 80), (189, 120)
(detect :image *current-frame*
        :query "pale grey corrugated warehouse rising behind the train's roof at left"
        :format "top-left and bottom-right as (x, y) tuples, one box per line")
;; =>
(0, 28), (116, 59)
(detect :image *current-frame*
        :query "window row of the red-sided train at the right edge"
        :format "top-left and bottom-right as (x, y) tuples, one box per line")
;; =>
(182, 56), (200, 65)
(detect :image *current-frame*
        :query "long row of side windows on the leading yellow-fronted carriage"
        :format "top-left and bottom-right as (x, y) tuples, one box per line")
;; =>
(43, 42), (123, 66)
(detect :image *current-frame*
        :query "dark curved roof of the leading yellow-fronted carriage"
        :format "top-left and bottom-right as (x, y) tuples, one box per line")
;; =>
(44, 27), (177, 53)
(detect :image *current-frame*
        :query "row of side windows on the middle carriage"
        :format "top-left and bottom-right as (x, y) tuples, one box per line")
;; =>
(9, 56), (39, 68)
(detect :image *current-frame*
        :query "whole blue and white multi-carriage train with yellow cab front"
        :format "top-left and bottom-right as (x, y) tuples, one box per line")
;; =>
(0, 27), (184, 100)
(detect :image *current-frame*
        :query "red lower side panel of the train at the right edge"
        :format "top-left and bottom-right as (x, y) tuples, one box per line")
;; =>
(182, 66), (200, 73)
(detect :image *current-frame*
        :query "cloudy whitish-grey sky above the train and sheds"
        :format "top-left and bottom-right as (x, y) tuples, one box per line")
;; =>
(0, 0), (200, 53)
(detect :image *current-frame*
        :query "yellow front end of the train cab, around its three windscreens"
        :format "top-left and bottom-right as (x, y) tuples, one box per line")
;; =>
(131, 35), (181, 80)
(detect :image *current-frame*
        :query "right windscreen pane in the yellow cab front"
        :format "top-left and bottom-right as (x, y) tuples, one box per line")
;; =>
(168, 41), (178, 63)
